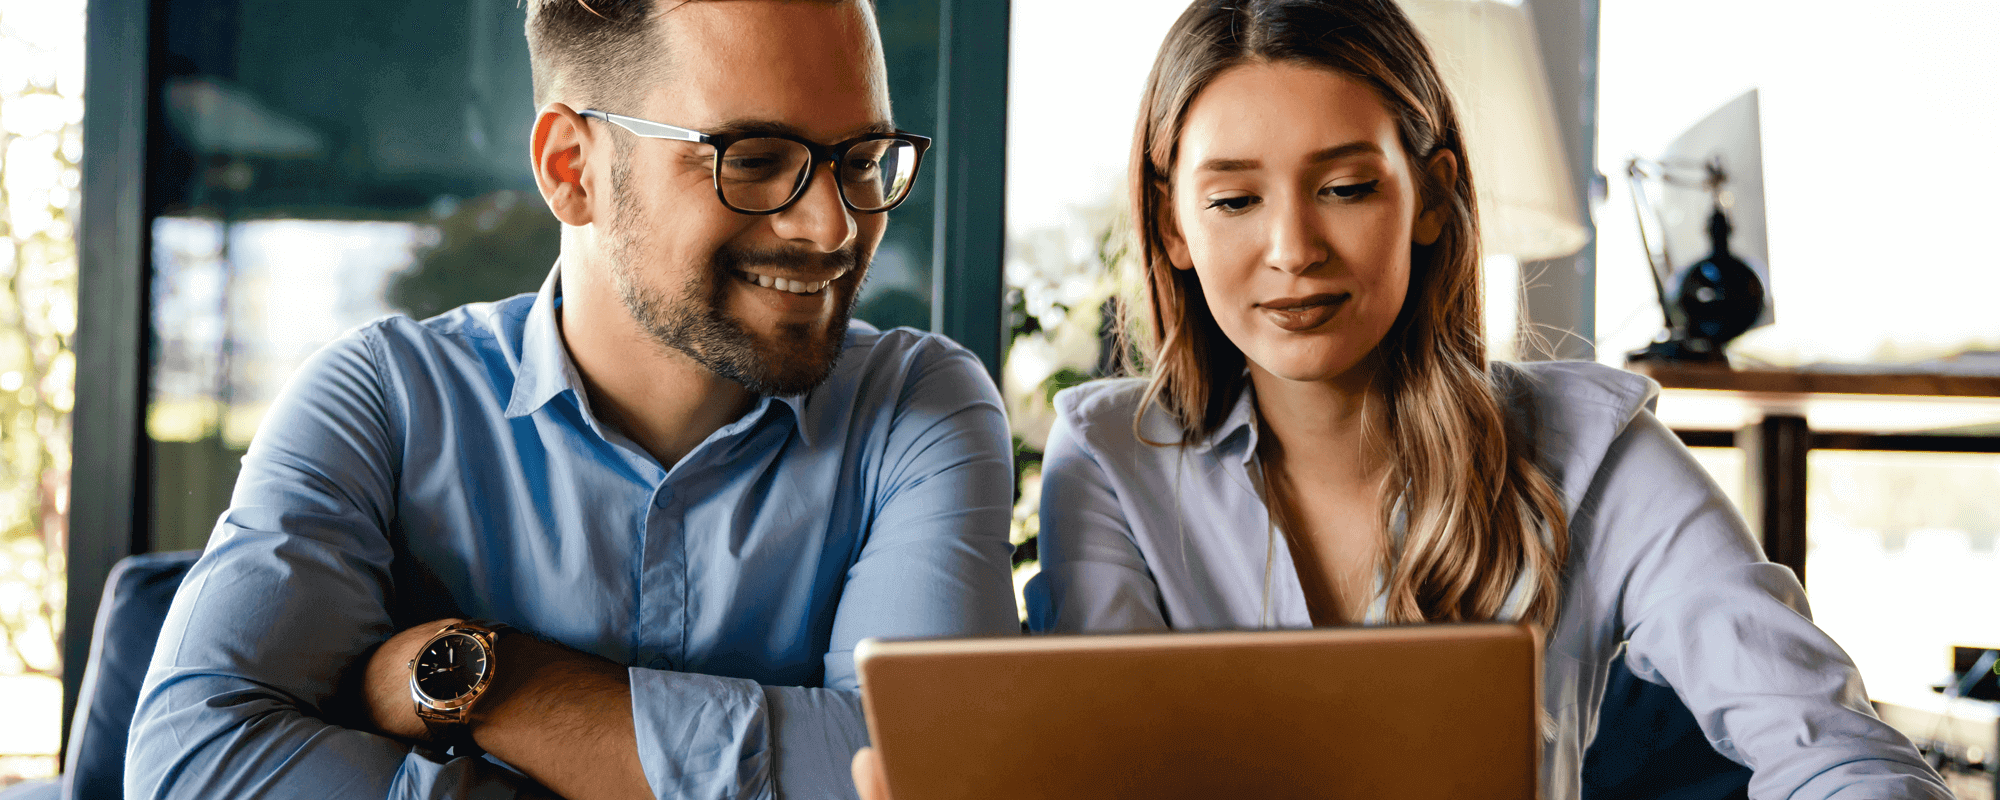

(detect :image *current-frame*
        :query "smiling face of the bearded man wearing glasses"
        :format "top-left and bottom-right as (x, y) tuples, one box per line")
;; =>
(604, 0), (890, 394)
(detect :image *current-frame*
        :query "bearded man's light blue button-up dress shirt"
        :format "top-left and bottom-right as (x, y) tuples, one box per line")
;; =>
(126, 274), (1020, 800)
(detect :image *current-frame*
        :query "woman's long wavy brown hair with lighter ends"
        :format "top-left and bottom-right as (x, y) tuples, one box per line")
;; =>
(1130, 0), (1568, 628)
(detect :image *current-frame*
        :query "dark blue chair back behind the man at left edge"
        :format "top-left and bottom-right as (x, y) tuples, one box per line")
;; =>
(0, 550), (202, 800)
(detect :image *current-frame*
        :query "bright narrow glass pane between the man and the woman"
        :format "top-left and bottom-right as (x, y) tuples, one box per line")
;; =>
(1000, 0), (1186, 600)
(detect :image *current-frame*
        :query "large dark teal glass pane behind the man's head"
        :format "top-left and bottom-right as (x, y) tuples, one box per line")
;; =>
(146, 0), (938, 550)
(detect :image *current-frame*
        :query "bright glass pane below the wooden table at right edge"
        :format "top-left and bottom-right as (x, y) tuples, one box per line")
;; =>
(1806, 450), (2000, 708)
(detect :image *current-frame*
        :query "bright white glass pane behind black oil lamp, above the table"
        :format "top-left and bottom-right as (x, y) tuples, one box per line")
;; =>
(1596, 0), (2000, 366)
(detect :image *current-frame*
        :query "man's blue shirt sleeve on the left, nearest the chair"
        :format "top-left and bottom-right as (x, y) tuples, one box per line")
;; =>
(126, 328), (550, 800)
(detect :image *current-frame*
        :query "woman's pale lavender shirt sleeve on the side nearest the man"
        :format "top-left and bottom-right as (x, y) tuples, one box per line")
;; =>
(1024, 394), (1166, 634)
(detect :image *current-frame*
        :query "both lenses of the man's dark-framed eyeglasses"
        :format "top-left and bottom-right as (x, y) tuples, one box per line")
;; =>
(716, 138), (916, 212)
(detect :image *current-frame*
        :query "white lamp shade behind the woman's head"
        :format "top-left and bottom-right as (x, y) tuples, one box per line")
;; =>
(1398, 0), (1590, 260)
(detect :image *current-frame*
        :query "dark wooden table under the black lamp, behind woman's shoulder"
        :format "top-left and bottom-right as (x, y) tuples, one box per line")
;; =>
(1626, 362), (2000, 584)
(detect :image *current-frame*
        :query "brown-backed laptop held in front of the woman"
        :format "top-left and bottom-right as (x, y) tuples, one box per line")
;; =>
(856, 624), (1542, 800)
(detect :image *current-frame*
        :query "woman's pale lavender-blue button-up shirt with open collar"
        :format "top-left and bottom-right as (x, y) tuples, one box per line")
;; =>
(1028, 362), (1950, 800)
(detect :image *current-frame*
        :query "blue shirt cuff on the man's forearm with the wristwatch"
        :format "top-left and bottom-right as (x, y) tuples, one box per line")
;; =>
(628, 666), (774, 800)
